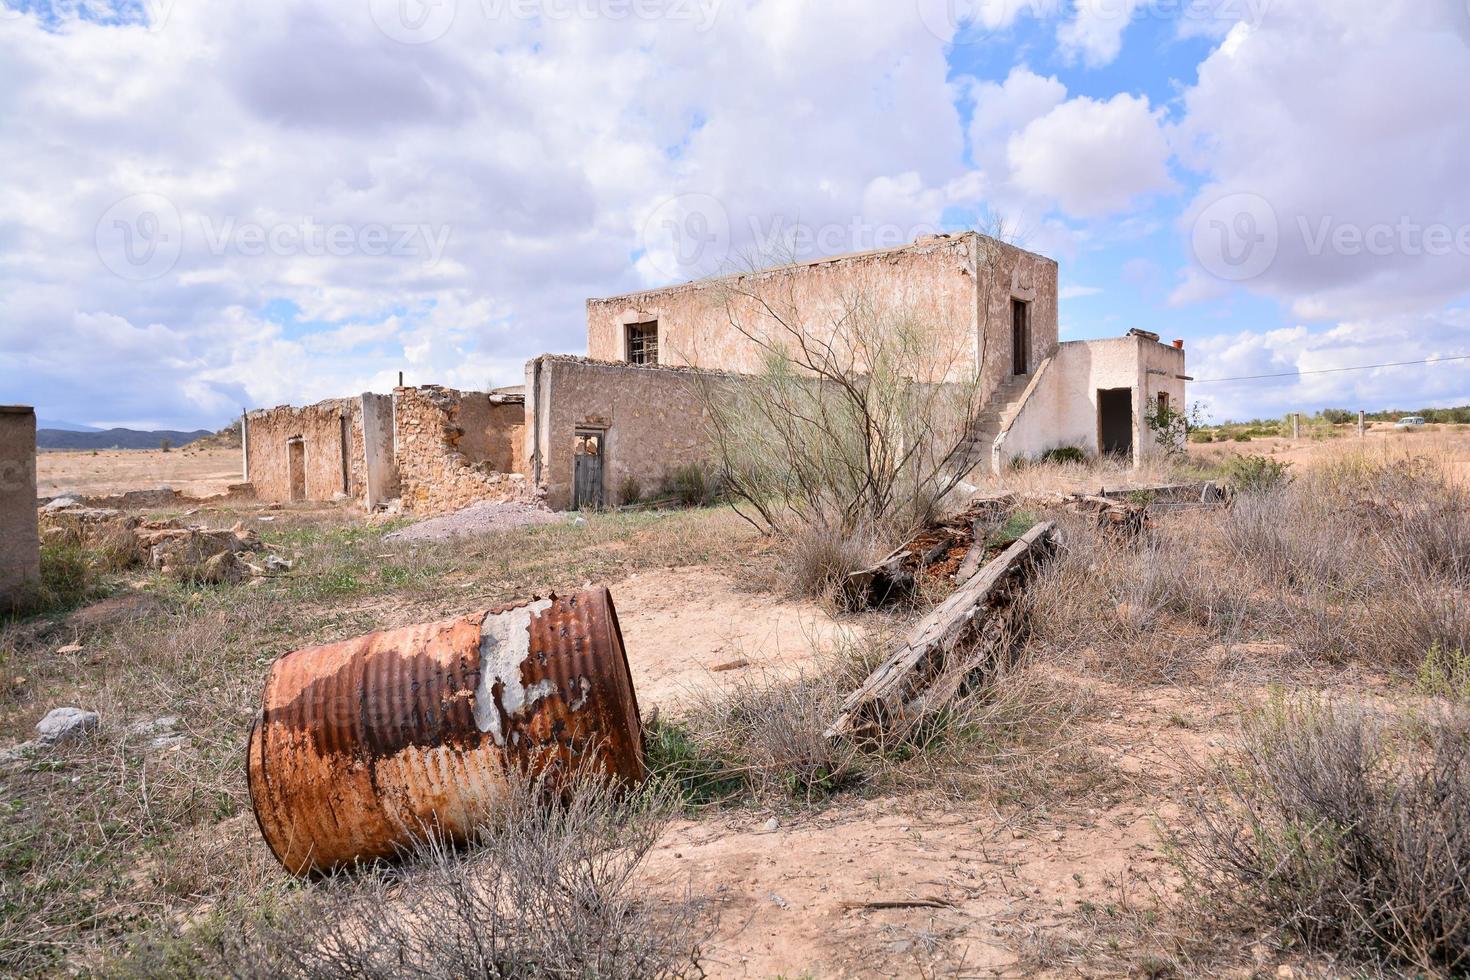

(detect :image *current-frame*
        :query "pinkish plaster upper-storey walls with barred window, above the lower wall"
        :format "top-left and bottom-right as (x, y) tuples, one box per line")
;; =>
(587, 234), (1057, 405)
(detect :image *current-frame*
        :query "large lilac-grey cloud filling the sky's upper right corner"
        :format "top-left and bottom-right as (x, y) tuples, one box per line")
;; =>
(1176, 0), (1470, 320)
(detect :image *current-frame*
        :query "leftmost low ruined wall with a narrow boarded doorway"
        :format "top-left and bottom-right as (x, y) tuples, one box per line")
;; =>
(245, 398), (365, 501)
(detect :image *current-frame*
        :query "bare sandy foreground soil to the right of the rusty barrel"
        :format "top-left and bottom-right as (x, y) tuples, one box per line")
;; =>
(650, 679), (1250, 977)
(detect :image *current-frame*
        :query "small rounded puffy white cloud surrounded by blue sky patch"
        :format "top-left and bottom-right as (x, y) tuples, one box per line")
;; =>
(1005, 94), (1173, 217)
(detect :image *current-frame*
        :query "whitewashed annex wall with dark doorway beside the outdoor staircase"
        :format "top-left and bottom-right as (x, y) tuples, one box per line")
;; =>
(997, 336), (1185, 466)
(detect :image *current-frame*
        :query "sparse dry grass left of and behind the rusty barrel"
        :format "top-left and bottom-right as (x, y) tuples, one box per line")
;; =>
(0, 510), (753, 973)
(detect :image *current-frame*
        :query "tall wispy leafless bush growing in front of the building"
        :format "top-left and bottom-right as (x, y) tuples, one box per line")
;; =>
(700, 276), (983, 594)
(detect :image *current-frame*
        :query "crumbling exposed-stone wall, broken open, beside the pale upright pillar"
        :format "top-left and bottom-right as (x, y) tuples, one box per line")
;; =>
(394, 385), (539, 514)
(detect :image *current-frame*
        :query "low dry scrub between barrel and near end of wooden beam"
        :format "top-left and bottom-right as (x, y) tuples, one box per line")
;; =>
(650, 639), (1091, 807)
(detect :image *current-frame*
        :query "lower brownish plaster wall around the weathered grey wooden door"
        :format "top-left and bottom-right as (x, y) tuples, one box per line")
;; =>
(526, 354), (710, 510)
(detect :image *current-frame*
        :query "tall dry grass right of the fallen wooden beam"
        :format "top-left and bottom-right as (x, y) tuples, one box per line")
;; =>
(1029, 443), (1470, 682)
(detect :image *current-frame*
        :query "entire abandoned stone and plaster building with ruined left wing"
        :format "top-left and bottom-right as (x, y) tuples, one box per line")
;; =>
(244, 232), (1188, 513)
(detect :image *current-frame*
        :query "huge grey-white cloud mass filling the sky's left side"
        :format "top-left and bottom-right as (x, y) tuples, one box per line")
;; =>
(0, 0), (994, 425)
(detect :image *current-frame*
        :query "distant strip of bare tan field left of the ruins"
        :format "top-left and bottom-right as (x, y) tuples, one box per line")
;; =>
(35, 447), (241, 497)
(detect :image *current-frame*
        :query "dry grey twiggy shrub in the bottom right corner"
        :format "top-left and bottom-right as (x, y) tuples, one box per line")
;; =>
(1169, 696), (1470, 976)
